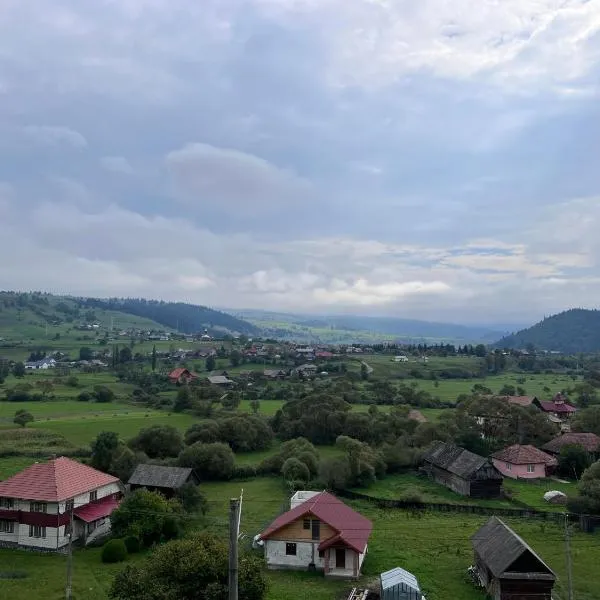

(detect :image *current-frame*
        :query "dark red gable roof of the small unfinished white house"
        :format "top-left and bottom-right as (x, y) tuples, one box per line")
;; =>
(260, 492), (373, 552)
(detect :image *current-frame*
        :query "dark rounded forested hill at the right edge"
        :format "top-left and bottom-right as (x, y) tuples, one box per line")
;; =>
(494, 308), (600, 354)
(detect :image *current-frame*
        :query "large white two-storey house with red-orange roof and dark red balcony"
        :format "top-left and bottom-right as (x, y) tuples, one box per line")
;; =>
(0, 456), (122, 551)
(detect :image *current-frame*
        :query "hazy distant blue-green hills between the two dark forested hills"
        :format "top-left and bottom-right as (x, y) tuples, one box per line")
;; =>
(234, 310), (502, 344)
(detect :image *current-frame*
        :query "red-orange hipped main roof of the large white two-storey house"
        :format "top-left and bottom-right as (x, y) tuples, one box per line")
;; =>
(0, 456), (119, 502)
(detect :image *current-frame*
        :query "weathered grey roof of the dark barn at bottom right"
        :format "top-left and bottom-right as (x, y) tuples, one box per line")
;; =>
(471, 517), (556, 580)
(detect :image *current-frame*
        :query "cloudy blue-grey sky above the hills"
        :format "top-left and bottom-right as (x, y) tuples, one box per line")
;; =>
(0, 0), (600, 324)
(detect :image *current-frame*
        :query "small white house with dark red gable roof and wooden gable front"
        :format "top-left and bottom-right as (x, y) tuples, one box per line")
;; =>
(260, 491), (373, 578)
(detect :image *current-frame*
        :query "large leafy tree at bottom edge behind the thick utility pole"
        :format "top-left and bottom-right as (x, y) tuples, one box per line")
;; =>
(109, 533), (267, 600)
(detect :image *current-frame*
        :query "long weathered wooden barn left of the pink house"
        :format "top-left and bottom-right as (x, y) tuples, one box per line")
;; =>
(422, 440), (503, 498)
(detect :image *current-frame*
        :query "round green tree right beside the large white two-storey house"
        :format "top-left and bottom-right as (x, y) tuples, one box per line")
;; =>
(110, 489), (182, 547)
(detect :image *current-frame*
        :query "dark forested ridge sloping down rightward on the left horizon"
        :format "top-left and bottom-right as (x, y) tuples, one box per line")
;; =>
(80, 298), (258, 335)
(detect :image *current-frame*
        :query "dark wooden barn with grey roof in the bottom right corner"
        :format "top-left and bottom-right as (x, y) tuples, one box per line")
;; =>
(471, 517), (556, 600)
